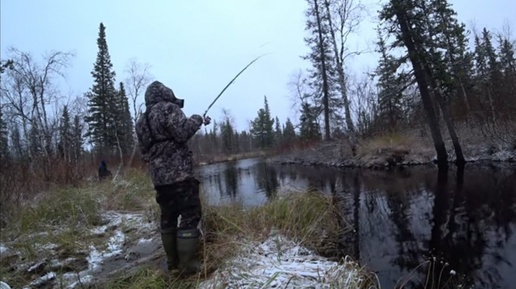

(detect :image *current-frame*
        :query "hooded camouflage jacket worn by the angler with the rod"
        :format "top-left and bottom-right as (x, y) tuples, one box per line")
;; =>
(136, 81), (203, 187)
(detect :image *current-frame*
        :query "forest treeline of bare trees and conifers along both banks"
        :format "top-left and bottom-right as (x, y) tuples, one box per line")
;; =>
(0, 0), (516, 212)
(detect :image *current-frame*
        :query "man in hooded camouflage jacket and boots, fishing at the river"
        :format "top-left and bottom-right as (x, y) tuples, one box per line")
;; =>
(136, 81), (211, 274)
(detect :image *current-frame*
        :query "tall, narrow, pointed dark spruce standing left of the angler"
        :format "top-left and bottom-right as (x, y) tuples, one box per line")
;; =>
(85, 23), (119, 154)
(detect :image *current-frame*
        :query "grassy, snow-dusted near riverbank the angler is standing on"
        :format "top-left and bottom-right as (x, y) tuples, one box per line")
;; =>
(0, 170), (375, 288)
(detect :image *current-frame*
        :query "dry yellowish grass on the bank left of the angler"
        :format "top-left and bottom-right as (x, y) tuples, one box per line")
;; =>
(0, 166), (156, 281)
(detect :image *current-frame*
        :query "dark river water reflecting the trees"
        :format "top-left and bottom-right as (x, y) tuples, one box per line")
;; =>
(197, 159), (516, 288)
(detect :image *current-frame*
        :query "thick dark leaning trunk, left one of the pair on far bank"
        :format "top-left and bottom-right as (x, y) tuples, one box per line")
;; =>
(396, 7), (448, 168)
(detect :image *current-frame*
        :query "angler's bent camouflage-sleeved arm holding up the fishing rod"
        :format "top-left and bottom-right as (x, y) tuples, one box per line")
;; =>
(165, 104), (203, 143)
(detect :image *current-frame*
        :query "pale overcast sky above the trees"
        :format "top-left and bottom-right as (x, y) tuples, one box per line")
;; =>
(0, 0), (516, 130)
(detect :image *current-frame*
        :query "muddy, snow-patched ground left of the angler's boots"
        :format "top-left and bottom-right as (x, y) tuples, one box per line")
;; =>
(0, 212), (164, 288)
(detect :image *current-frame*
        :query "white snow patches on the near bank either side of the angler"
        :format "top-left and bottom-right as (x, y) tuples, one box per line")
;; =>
(0, 212), (374, 289)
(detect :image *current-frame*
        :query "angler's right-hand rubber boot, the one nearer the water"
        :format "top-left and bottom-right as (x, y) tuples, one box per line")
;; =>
(177, 228), (201, 275)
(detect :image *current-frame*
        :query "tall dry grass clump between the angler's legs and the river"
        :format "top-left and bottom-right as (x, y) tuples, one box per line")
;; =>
(203, 192), (350, 272)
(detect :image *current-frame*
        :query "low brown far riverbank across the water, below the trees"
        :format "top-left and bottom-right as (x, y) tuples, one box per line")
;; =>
(270, 130), (516, 169)
